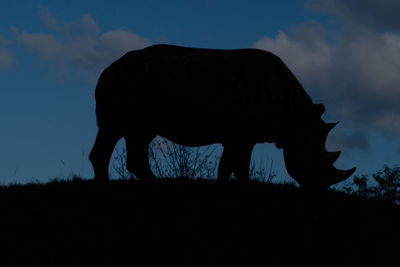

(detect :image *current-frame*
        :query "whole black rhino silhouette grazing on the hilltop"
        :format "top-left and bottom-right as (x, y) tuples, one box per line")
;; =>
(89, 45), (355, 187)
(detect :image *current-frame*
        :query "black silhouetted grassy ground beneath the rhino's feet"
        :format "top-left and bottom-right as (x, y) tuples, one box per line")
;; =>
(0, 179), (400, 267)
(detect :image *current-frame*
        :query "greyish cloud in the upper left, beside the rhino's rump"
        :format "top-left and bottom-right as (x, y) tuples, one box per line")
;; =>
(17, 9), (151, 74)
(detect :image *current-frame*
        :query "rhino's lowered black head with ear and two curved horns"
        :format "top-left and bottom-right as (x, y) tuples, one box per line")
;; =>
(283, 104), (356, 188)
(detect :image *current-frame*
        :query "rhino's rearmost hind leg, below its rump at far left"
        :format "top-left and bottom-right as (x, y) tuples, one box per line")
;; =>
(89, 129), (121, 181)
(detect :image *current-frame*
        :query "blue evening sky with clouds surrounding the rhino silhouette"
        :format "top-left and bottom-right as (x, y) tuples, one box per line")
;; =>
(0, 0), (400, 183)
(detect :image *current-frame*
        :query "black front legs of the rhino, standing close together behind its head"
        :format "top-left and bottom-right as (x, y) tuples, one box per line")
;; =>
(217, 143), (255, 182)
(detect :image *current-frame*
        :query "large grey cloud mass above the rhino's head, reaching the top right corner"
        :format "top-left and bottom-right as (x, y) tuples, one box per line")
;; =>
(254, 0), (400, 152)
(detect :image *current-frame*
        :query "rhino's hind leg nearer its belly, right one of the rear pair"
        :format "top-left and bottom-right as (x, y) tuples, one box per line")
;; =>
(125, 134), (155, 180)
